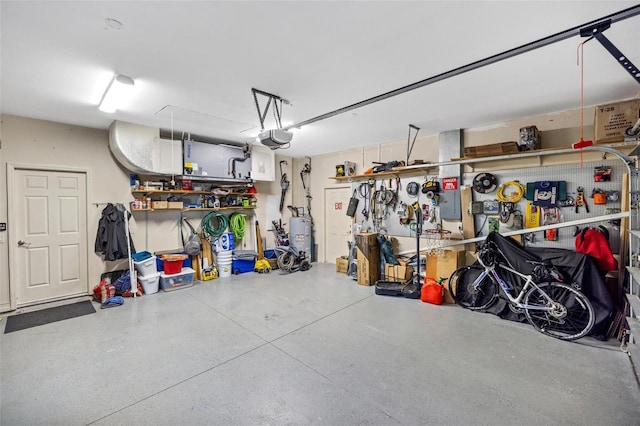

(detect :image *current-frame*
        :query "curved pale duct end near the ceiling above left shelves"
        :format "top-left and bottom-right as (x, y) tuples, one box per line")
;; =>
(109, 121), (182, 175)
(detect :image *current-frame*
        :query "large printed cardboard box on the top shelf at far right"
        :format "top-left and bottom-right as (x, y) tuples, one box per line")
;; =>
(593, 99), (640, 142)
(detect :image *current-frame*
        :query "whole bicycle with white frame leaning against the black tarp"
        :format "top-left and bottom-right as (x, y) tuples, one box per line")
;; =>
(449, 242), (595, 340)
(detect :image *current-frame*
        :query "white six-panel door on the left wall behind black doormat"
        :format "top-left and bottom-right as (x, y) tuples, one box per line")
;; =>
(10, 168), (88, 306)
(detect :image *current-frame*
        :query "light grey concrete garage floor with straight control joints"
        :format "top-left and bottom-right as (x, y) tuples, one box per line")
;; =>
(0, 264), (640, 425)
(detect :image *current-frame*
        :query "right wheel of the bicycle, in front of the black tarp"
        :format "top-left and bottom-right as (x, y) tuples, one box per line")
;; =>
(523, 283), (595, 340)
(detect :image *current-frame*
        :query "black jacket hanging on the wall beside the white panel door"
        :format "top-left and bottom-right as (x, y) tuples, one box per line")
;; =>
(95, 203), (136, 261)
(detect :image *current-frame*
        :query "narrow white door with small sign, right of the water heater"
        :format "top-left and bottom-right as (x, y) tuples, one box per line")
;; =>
(324, 187), (353, 263)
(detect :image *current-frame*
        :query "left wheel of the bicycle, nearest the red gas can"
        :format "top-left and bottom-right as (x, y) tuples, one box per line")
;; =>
(449, 265), (498, 311)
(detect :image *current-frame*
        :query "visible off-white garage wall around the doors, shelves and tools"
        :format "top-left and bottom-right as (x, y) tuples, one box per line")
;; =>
(0, 102), (620, 311)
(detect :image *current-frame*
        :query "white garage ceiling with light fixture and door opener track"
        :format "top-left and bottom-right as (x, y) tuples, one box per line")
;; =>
(0, 0), (640, 157)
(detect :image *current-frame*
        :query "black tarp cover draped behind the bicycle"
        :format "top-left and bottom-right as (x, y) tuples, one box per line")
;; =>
(478, 232), (614, 334)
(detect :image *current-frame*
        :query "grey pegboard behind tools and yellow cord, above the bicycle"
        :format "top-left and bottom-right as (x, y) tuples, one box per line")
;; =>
(463, 160), (627, 253)
